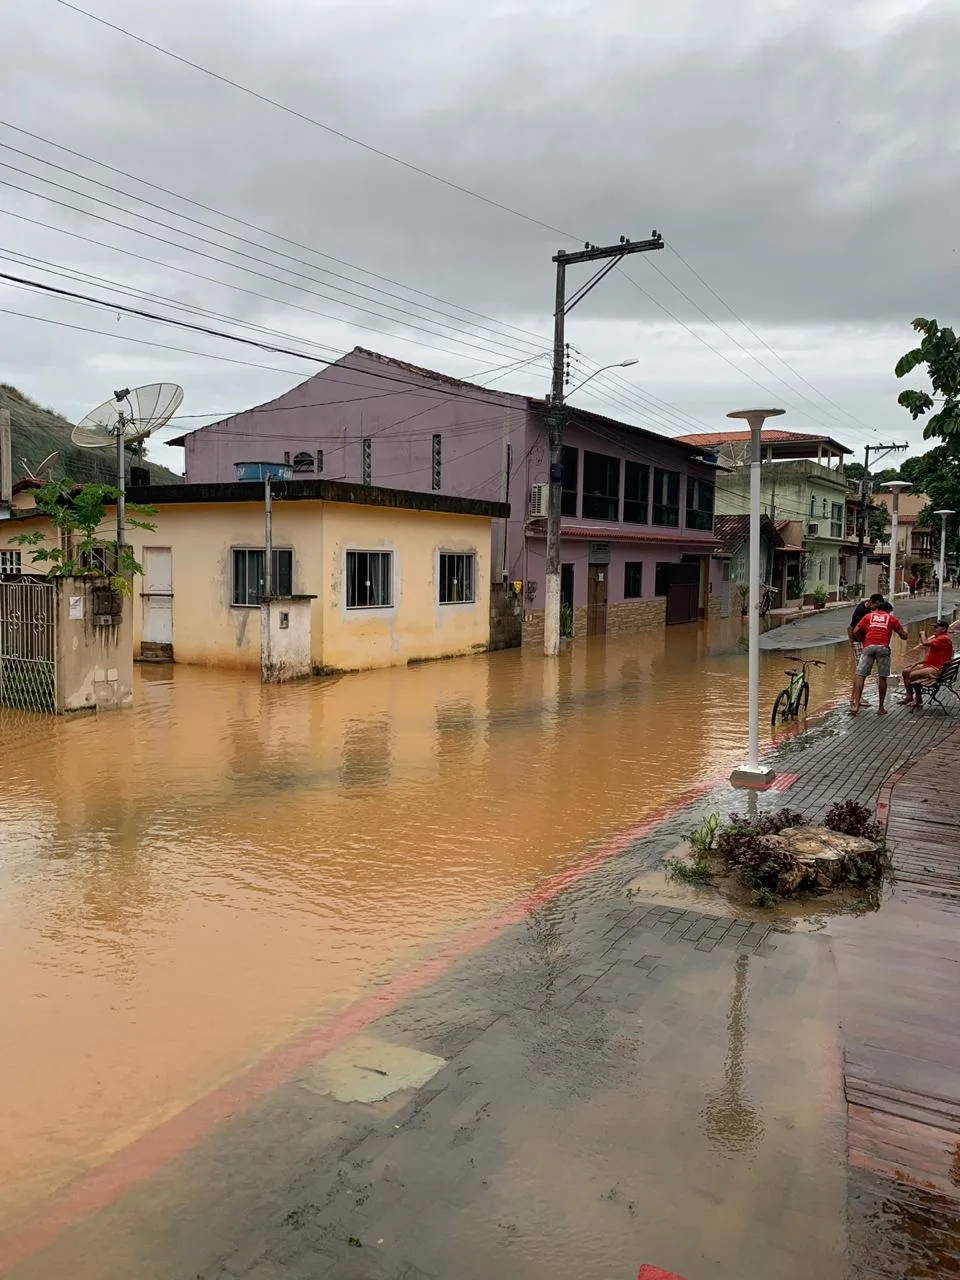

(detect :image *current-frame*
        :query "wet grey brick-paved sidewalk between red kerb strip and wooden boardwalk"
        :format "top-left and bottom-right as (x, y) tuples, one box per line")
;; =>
(12, 712), (956, 1280)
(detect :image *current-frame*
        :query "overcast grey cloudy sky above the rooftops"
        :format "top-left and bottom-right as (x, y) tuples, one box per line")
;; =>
(0, 0), (960, 470)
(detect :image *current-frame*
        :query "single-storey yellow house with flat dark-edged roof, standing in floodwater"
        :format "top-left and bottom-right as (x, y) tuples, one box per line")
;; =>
(0, 480), (508, 671)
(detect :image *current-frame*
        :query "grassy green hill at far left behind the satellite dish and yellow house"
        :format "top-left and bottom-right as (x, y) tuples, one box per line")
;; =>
(0, 383), (183, 484)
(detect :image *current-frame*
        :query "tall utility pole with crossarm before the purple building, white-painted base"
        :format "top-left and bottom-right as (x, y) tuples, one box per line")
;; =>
(543, 232), (663, 658)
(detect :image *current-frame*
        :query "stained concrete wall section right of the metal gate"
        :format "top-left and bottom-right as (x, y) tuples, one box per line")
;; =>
(55, 578), (133, 712)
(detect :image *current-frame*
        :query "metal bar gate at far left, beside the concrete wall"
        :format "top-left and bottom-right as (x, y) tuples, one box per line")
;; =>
(0, 577), (56, 712)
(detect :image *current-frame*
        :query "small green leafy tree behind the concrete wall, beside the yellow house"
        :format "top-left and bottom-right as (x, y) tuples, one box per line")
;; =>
(10, 480), (156, 591)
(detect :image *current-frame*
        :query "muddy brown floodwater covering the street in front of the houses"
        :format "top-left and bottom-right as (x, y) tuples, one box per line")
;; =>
(0, 620), (926, 1225)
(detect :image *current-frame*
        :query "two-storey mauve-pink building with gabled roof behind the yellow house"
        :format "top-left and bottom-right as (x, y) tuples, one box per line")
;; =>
(172, 347), (721, 643)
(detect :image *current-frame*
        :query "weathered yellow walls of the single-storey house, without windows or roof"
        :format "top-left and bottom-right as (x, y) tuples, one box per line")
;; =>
(0, 502), (490, 671)
